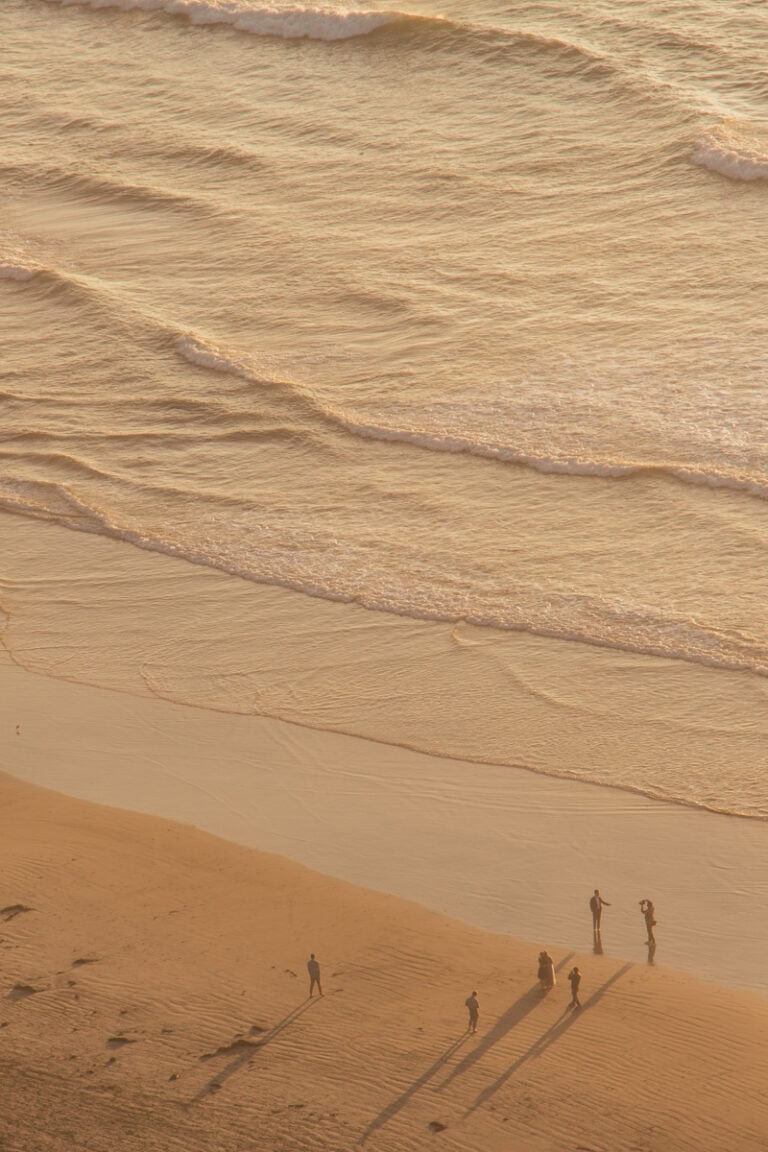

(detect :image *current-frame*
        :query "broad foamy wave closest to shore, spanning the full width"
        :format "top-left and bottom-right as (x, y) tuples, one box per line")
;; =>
(0, 460), (768, 676)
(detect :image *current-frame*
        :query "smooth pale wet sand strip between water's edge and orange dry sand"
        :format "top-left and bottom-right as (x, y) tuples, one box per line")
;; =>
(0, 657), (768, 995)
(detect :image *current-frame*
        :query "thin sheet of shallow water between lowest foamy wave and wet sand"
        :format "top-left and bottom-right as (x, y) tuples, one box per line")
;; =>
(6, 513), (768, 818)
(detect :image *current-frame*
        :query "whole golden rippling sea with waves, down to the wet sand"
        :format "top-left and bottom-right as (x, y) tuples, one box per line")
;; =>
(0, 0), (768, 819)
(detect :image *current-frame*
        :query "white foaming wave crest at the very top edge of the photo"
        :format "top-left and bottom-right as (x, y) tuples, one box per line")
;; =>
(54, 0), (403, 40)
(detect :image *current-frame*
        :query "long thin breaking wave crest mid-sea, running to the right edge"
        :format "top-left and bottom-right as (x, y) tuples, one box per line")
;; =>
(175, 333), (768, 500)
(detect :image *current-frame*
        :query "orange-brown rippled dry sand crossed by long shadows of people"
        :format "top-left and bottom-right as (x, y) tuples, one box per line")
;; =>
(0, 778), (768, 1152)
